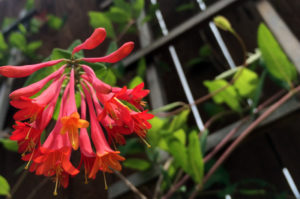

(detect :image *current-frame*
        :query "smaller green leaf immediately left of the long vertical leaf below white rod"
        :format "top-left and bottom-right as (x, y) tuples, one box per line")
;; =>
(168, 139), (188, 172)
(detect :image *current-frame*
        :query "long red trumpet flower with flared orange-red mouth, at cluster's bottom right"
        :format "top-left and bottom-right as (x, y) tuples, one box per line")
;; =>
(82, 85), (125, 178)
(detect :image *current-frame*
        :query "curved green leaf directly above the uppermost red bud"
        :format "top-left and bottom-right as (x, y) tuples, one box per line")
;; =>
(89, 11), (116, 38)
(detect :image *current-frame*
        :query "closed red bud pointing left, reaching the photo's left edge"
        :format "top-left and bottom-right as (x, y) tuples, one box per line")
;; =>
(0, 59), (63, 78)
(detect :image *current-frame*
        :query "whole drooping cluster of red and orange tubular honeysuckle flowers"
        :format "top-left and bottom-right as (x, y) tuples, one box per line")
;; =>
(0, 28), (153, 195)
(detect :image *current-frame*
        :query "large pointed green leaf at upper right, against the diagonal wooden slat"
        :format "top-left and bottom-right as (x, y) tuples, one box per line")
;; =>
(258, 24), (297, 85)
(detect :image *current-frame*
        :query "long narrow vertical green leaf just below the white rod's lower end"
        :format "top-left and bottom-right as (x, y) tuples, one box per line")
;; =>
(187, 131), (204, 183)
